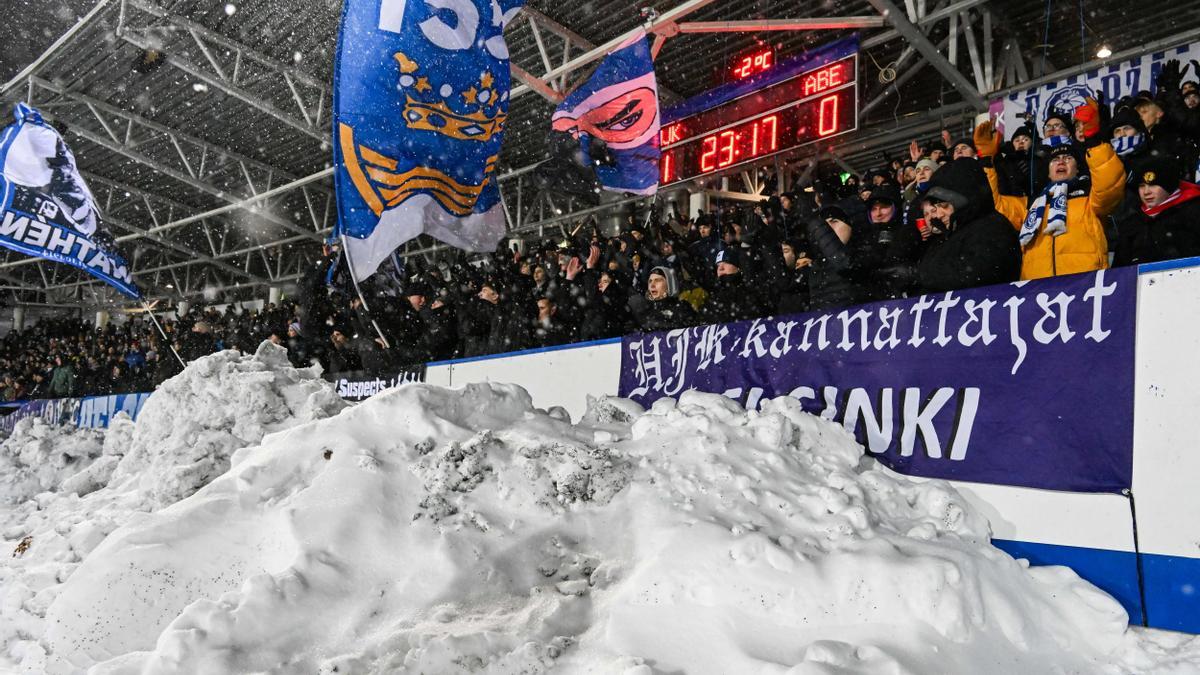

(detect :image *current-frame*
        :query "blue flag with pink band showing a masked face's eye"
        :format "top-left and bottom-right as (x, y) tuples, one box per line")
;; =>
(552, 31), (662, 195)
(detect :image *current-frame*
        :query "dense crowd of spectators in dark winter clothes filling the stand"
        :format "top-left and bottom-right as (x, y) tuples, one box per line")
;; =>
(7, 61), (1200, 399)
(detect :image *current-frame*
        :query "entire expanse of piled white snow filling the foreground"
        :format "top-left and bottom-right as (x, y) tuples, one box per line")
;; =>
(0, 345), (1200, 675)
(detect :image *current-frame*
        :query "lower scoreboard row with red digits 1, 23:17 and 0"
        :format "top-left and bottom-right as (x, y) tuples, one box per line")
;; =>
(659, 86), (857, 185)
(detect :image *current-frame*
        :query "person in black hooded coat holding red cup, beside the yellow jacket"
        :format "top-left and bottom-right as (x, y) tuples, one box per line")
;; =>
(917, 157), (1021, 292)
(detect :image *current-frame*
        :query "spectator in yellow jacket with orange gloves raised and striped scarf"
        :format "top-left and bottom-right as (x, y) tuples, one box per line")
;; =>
(974, 98), (1124, 279)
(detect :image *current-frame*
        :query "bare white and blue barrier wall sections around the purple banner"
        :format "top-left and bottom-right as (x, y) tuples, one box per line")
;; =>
(0, 258), (1200, 633)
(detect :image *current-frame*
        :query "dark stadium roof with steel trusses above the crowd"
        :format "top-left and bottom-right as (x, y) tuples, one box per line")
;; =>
(0, 0), (1200, 306)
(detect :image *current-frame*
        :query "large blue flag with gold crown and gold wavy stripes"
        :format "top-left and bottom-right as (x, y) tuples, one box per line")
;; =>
(334, 0), (524, 280)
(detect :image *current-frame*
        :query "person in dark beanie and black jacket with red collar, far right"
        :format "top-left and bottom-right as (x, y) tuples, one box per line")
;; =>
(1112, 157), (1200, 265)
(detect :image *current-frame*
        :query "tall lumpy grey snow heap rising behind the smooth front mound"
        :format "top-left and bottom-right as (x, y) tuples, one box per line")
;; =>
(113, 341), (347, 508)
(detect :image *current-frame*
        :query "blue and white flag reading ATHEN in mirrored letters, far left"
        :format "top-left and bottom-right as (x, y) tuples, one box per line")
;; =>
(0, 103), (142, 298)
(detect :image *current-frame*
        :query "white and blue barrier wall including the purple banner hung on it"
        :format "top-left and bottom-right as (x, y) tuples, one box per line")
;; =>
(2, 258), (1200, 633)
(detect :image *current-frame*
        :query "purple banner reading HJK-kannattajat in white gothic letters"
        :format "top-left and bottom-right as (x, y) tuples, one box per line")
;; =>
(620, 268), (1138, 492)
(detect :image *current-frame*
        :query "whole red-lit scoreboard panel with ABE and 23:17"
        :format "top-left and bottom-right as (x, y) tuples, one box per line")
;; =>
(659, 53), (858, 185)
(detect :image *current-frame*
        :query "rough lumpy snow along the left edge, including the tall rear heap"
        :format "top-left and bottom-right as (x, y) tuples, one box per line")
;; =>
(0, 344), (346, 673)
